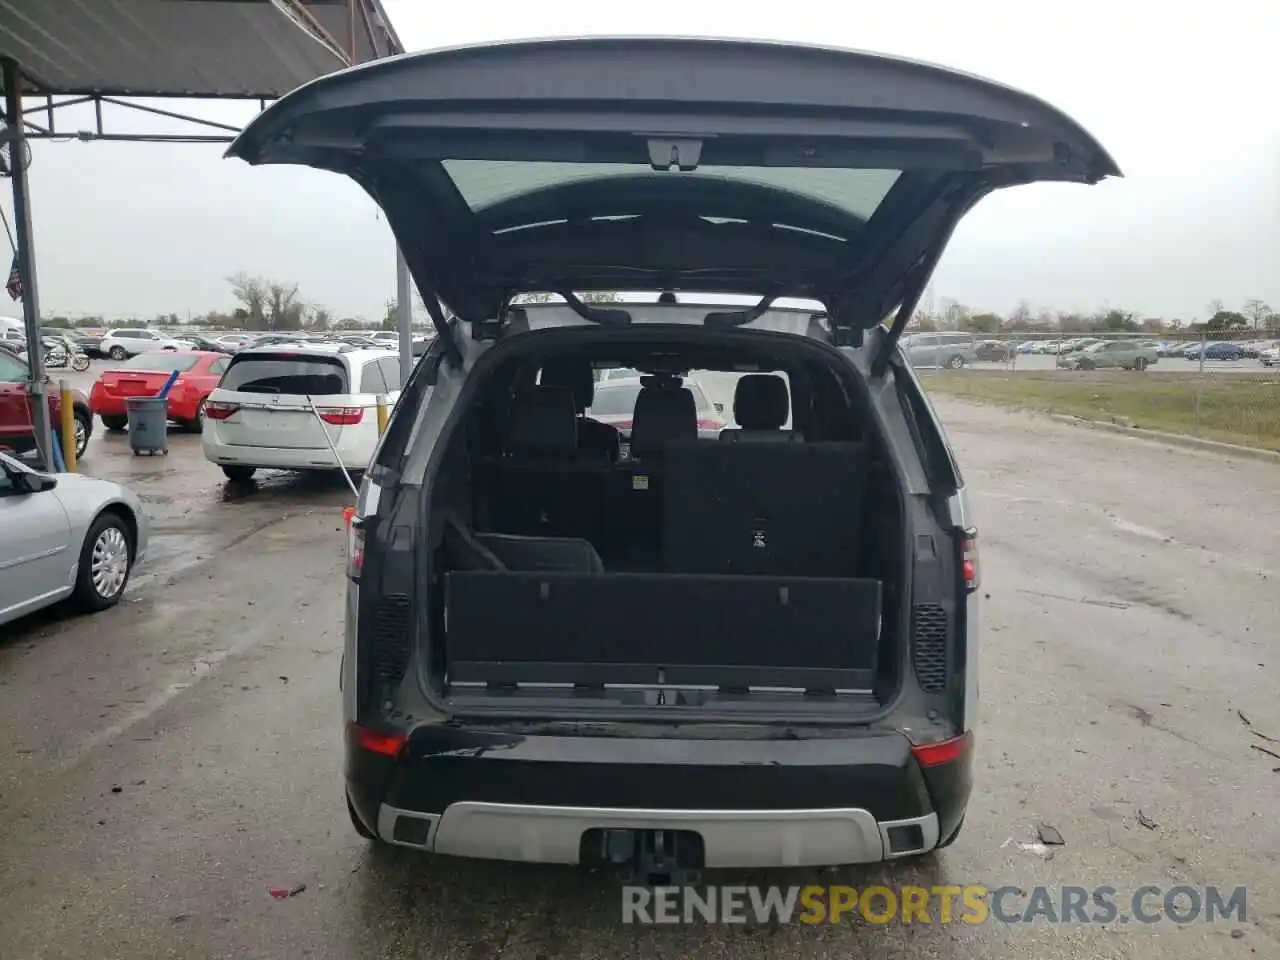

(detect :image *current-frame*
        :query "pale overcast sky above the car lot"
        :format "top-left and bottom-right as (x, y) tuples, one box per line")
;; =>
(0, 0), (1280, 319)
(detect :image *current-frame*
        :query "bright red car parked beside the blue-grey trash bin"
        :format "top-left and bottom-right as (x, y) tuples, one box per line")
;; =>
(88, 349), (230, 433)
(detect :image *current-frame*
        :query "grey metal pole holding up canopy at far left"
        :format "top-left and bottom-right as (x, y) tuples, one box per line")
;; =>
(0, 56), (54, 470)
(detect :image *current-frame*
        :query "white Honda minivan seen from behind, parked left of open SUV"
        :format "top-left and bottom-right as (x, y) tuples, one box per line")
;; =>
(204, 343), (401, 480)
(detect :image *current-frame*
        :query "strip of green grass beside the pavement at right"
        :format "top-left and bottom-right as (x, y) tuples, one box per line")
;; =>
(920, 370), (1280, 451)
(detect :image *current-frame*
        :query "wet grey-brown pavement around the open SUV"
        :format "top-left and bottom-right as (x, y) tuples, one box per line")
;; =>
(0, 401), (1280, 960)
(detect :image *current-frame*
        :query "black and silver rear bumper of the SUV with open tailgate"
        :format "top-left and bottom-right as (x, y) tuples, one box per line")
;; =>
(347, 727), (972, 868)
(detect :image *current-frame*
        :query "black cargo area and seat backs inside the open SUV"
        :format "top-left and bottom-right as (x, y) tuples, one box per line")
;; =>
(430, 335), (901, 709)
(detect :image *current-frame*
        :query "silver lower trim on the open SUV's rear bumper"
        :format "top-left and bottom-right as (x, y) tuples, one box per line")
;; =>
(378, 803), (938, 868)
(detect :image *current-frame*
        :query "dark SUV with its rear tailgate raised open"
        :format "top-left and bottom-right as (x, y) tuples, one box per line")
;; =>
(230, 38), (1119, 869)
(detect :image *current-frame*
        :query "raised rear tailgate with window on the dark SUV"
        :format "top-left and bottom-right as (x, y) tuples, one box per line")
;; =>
(228, 37), (1119, 343)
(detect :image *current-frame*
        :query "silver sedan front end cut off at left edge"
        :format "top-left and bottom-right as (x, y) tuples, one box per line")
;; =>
(0, 453), (150, 623)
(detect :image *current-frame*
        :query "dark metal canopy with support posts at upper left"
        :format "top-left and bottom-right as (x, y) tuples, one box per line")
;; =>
(0, 0), (412, 468)
